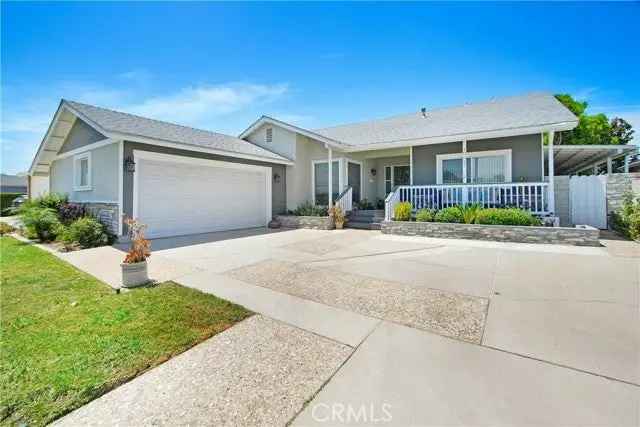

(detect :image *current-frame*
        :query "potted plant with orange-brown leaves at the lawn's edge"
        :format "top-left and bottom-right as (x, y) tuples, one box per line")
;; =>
(120, 218), (151, 288)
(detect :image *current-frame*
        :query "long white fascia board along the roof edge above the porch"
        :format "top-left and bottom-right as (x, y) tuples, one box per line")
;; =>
(344, 122), (578, 152)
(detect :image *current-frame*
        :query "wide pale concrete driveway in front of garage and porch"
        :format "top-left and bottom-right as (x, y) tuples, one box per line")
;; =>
(57, 230), (640, 426)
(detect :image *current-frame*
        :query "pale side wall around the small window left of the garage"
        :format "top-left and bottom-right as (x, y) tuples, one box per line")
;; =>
(50, 143), (118, 202)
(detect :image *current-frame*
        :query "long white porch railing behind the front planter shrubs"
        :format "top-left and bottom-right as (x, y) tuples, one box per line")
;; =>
(385, 182), (549, 221)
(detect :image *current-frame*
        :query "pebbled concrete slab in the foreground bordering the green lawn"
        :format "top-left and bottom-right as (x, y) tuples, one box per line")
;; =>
(54, 315), (352, 427)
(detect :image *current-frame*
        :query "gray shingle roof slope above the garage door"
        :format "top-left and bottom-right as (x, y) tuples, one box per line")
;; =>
(64, 100), (289, 161)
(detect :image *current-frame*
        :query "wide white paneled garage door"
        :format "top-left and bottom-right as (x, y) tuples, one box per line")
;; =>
(133, 151), (271, 237)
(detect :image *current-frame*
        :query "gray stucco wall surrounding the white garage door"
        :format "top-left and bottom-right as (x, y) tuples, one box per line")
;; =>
(122, 141), (287, 227)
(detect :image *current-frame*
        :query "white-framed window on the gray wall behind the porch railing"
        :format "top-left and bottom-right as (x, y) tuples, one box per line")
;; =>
(436, 150), (511, 184)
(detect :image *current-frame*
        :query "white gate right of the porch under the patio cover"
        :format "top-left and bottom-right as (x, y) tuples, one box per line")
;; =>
(569, 175), (607, 229)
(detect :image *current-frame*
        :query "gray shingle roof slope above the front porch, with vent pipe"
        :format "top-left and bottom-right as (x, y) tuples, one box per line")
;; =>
(313, 93), (578, 145)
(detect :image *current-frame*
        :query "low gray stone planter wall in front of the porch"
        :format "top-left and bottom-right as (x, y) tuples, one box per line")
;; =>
(382, 221), (600, 246)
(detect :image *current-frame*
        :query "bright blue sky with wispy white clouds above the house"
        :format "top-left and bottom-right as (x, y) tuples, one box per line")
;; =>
(0, 2), (640, 173)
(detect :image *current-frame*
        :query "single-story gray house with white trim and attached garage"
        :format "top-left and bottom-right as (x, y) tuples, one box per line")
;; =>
(29, 93), (620, 237)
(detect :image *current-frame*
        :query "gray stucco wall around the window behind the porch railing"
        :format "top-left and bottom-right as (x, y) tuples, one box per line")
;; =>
(413, 134), (543, 185)
